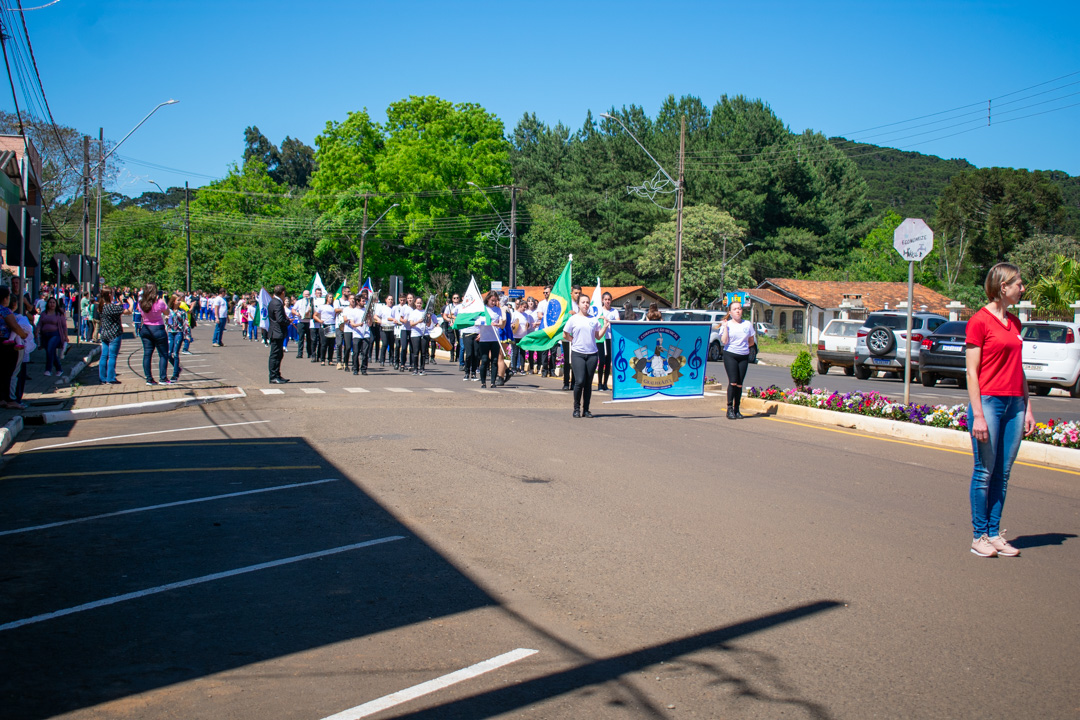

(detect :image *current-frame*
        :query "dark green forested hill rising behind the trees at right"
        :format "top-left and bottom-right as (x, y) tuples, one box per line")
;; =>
(842, 137), (1080, 235)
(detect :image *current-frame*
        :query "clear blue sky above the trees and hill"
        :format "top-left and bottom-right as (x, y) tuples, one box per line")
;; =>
(10, 0), (1080, 195)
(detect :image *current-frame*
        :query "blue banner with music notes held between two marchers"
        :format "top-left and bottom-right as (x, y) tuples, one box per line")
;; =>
(611, 322), (712, 400)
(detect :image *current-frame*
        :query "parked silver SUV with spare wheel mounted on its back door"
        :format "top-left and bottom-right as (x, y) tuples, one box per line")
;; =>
(855, 311), (948, 381)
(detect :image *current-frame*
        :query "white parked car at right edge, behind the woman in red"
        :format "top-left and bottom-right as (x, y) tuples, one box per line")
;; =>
(1021, 321), (1080, 397)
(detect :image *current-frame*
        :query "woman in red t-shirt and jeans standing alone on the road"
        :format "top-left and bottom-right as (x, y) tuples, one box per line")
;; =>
(967, 262), (1035, 557)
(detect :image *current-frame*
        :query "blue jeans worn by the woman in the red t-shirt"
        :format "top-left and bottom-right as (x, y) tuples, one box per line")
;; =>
(968, 395), (1027, 538)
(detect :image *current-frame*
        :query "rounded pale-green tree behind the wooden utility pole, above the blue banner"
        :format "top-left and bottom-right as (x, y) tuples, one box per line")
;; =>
(637, 205), (746, 305)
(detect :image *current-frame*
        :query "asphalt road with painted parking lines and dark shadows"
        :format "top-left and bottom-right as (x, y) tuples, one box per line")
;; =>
(0, 328), (1080, 720)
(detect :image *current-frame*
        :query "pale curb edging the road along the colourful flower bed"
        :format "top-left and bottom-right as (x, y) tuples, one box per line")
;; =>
(742, 397), (1080, 470)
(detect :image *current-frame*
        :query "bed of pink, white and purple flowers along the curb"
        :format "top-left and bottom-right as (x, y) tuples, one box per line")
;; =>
(746, 385), (1080, 448)
